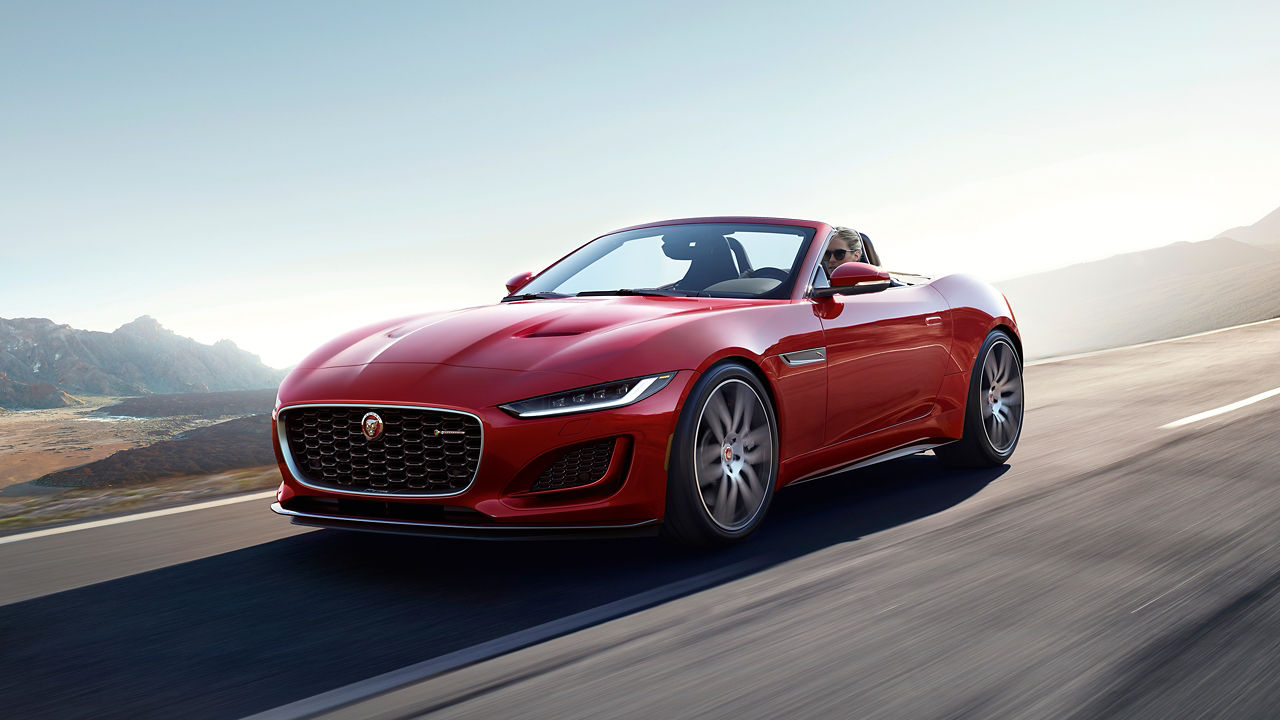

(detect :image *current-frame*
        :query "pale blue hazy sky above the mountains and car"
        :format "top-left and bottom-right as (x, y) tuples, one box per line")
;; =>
(0, 0), (1280, 368)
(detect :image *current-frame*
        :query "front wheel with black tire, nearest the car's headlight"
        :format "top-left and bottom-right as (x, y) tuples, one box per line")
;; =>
(662, 363), (778, 547)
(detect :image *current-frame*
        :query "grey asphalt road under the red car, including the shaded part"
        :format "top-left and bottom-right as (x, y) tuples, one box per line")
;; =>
(0, 322), (1280, 720)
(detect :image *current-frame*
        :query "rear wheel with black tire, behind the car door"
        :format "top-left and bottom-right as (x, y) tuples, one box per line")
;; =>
(933, 331), (1023, 468)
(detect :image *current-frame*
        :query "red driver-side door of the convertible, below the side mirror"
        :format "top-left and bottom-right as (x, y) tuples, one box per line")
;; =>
(813, 284), (951, 445)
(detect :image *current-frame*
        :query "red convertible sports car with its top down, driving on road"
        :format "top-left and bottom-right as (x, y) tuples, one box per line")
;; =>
(271, 218), (1023, 544)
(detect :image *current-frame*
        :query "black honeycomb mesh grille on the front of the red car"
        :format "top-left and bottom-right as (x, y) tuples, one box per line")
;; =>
(280, 407), (481, 495)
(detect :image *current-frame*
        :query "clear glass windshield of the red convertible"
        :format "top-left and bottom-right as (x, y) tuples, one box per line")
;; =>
(511, 224), (814, 300)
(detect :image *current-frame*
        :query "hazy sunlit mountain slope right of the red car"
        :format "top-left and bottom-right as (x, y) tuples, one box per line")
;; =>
(996, 203), (1280, 359)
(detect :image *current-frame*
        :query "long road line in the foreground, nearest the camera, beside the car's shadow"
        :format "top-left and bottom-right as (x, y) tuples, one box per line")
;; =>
(244, 561), (759, 720)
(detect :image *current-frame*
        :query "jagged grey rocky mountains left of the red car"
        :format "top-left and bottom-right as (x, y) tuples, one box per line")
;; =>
(0, 315), (283, 409)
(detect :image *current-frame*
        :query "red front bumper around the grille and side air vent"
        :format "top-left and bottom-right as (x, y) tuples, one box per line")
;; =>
(271, 370), (695, 530)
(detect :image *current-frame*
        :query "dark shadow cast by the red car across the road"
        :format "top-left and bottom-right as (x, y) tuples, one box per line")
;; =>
(0, 456), (1007, 720)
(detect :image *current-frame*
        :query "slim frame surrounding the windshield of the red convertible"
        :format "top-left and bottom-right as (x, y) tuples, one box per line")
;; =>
(503, 218), (828, 301)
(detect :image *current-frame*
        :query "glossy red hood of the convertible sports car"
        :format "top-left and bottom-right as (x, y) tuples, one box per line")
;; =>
(298, 297), (746, 378)
